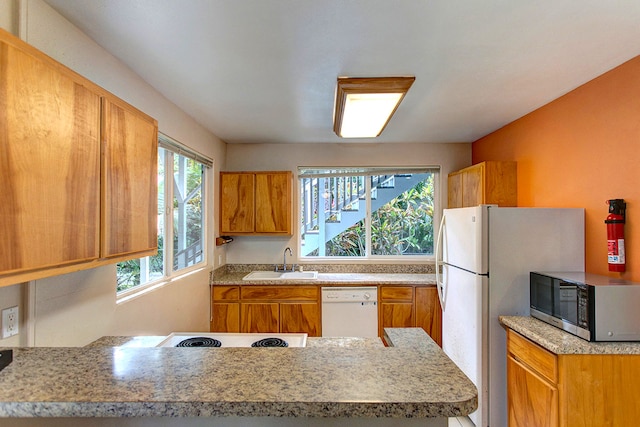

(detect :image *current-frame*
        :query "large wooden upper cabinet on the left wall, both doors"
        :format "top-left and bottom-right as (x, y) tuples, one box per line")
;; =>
(0, 30), (157, 286)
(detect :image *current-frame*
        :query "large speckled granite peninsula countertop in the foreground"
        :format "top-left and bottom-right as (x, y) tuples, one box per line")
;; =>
(0, 328), (477, 418)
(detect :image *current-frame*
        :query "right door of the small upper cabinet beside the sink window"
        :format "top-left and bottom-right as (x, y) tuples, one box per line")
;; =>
(255, 172), (292, 234)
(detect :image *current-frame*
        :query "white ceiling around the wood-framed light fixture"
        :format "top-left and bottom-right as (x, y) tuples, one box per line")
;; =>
(46, 0), (640, 143)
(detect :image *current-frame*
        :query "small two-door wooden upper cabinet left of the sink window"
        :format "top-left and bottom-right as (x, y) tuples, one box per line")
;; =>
(220, 171), (293, 235)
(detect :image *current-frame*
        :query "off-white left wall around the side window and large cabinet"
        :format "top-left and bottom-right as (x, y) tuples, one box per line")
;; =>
(0, 0), (225, 346)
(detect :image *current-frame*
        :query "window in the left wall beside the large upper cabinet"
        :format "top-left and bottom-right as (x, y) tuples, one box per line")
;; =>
(117, 135), (211, 293)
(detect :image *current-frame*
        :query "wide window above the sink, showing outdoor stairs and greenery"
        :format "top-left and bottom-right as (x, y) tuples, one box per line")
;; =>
(298, 167), (439, 259)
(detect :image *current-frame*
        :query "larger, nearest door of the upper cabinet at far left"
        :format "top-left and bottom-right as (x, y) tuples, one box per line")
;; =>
(0, 33), (100, 275)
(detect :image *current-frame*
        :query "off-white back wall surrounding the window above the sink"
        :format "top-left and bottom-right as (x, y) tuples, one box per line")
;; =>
(224, 143), (471, 264)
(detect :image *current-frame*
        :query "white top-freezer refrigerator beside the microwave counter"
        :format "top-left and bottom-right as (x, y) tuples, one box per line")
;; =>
(436, 205), (585, 427)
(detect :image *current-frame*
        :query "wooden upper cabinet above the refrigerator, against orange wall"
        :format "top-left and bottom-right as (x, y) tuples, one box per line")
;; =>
(448, 161), (518, 208)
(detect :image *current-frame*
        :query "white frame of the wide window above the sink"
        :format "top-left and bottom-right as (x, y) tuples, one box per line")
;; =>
(296, 165), (442, 264)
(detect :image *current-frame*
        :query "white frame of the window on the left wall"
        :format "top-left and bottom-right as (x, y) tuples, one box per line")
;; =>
(116, 132), (213, 303)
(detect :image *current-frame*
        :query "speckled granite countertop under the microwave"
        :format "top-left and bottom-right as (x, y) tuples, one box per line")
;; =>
(499, 316), (640, 354)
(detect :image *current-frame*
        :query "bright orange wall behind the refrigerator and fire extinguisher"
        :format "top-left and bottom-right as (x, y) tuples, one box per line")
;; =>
(472, 56), (640, 282)
